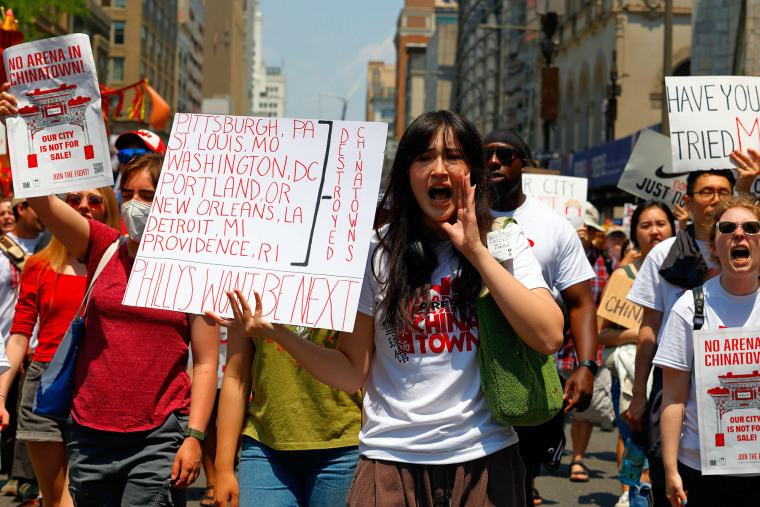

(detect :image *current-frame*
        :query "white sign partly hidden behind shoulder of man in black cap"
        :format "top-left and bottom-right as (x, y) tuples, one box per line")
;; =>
(522, 173), (588, 229)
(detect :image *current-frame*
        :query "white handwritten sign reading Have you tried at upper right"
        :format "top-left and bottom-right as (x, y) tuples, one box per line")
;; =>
(665, 76), (760, 173)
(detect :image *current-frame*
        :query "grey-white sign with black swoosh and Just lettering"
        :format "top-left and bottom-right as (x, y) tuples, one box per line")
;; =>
(617, 129), (689, 208)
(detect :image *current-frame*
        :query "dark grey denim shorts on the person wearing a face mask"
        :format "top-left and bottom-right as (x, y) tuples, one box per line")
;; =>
(66, 414), (188, 507)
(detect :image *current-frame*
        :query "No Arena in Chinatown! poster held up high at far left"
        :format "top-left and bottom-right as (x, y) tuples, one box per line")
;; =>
(3, 34), (113, 197)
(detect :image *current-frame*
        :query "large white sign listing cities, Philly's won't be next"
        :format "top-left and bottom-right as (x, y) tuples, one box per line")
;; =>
(124, 113), (388, 331)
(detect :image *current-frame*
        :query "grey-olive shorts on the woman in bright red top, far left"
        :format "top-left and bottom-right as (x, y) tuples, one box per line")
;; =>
(16, 361), (66, 442)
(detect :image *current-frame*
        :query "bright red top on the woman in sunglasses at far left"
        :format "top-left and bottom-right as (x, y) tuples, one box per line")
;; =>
(11, 257), (87, 362)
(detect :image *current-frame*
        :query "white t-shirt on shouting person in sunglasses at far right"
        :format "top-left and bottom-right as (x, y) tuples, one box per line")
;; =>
(650, 278), (760, 470)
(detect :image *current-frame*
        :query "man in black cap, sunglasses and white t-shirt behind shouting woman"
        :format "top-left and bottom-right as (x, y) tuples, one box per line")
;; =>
(485, 129), (597, 505)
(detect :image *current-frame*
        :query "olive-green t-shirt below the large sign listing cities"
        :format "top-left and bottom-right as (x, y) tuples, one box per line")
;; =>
(243, 326), (362, 451)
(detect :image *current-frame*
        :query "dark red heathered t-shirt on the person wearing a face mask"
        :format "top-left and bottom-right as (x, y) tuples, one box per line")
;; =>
(72, 220), (190, 432)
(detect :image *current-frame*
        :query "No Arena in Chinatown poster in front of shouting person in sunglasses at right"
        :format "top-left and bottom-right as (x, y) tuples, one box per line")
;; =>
(694, 327), (760, 475)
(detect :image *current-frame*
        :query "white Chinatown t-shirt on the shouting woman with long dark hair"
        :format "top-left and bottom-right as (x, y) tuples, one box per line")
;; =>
(359, 225), (546, 464)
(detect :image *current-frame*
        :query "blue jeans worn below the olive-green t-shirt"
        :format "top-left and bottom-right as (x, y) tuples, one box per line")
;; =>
(238, 436), (359, 507)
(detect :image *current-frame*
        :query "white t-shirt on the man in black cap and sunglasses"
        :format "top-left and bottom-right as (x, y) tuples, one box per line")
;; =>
(491, 196), (596, 291)
